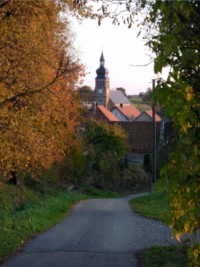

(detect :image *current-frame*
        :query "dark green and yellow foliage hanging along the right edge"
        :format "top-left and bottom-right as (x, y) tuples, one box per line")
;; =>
(148, 1), (200, 264)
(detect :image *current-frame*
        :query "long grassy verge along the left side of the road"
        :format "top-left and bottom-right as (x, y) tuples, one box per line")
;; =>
(0, 183), (121, 262)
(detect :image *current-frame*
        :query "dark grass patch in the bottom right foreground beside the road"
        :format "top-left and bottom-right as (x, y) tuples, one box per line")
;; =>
(143, 246), (187, 267)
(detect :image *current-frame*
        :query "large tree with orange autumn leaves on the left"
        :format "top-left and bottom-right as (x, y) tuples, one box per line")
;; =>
(0, 0), (87, 183)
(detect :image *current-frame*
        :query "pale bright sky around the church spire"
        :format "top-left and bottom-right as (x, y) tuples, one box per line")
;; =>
(72, 16), (161, 95)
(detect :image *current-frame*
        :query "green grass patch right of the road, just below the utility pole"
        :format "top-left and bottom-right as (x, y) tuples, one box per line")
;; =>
(130, 190), (169, 221)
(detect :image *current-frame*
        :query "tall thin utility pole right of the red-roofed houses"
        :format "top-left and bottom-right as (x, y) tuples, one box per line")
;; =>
(152, 79), (156, 183)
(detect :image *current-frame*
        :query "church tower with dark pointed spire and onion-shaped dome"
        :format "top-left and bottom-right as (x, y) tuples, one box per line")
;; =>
(95, 52), (110, 109)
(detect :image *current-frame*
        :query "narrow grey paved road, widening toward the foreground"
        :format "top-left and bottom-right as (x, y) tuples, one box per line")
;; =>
(3, 196), (177, 267)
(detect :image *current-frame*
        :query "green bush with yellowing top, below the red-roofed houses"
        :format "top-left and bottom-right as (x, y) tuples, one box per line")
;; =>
(83, 121), (127, 190)
